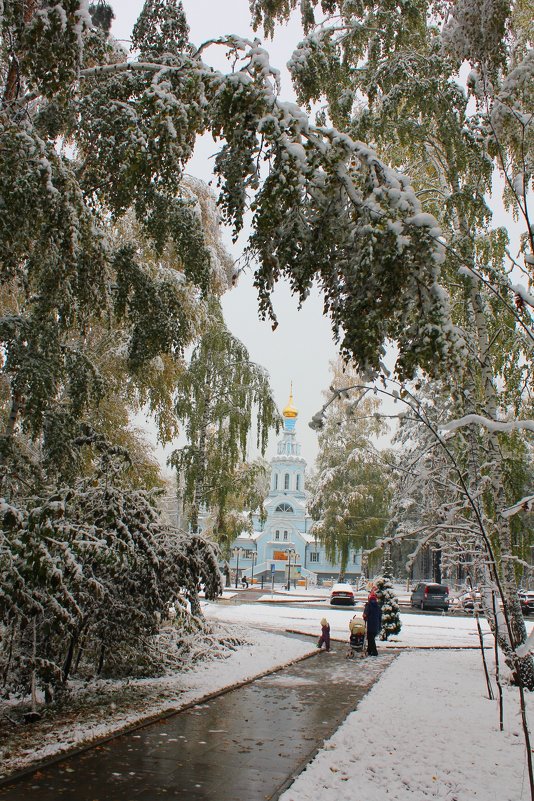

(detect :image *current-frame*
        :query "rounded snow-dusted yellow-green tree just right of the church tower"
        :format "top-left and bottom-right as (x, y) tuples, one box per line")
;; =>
(309, 360), (389, 573)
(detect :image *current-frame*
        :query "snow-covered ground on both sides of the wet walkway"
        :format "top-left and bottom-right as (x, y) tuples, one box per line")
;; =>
(4, 596), (534, 801)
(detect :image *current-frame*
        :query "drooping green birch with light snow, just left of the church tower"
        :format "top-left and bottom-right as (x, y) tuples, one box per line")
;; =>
(170, 299), (280, 542)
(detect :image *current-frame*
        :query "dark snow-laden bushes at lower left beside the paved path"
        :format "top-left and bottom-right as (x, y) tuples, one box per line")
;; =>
(0, 440), (222, 699)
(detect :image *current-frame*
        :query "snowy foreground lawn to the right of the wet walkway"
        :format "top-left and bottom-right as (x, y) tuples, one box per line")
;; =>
(280, 651), (534, 801)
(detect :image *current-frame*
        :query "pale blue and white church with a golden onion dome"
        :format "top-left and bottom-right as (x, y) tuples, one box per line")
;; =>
(229, 392), (361, 584)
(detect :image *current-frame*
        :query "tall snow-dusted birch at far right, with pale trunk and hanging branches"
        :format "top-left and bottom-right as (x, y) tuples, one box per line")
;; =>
(252, 0), (534, 687)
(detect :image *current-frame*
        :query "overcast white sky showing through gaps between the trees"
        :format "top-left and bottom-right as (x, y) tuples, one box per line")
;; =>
(111, 0), (336, 466)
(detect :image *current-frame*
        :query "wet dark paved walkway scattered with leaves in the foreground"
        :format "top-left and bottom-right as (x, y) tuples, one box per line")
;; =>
(0, 644), (394, 801)
